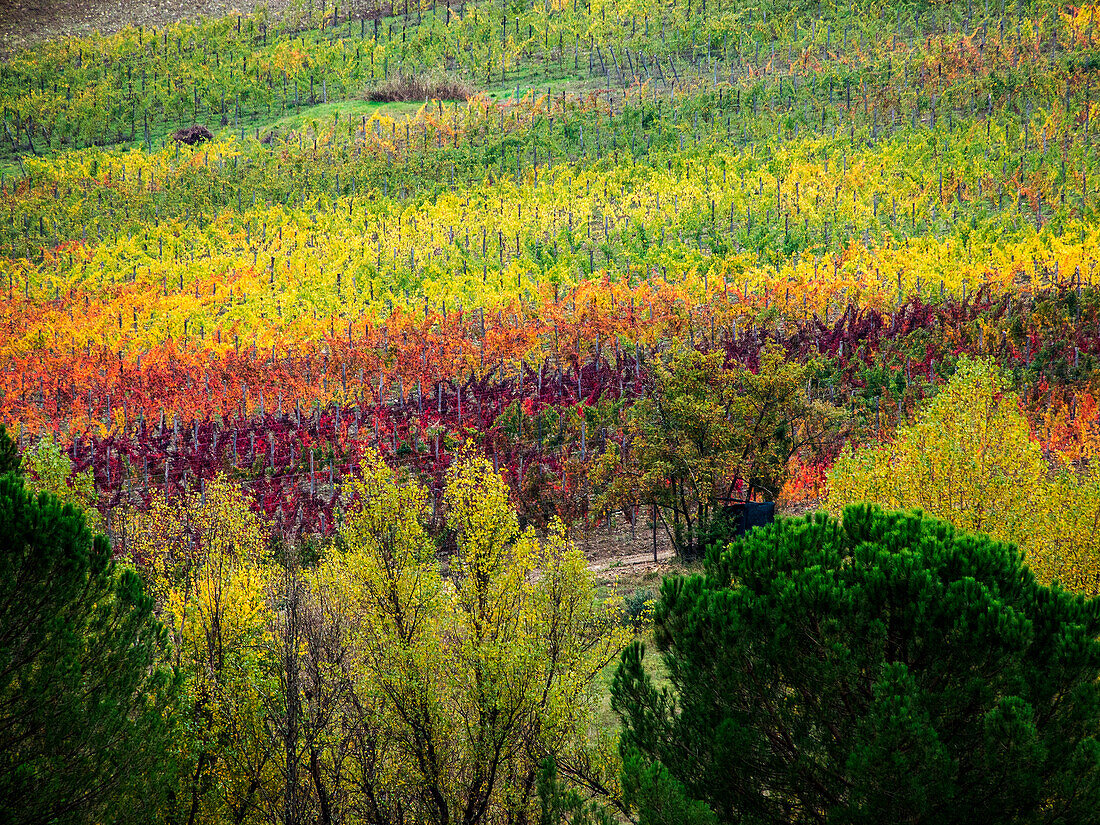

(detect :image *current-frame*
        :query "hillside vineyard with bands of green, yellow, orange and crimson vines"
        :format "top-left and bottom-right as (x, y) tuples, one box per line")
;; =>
(0, 0), (1100, 543)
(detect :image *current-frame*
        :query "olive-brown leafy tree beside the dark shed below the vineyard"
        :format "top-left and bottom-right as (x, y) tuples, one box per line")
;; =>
(592, 347), (840, 557)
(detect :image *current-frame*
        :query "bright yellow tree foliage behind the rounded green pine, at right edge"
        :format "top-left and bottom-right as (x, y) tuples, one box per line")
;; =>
(828, 359), (1100, 594)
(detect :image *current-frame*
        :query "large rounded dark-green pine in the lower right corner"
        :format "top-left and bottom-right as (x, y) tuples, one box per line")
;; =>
(612, 505), (1100, 825)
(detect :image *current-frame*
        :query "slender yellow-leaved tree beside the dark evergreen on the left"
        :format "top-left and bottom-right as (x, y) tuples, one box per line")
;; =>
(124, 477), (282, 823)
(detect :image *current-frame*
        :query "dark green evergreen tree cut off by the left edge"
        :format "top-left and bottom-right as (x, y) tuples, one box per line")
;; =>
(0, 473), (177, 823)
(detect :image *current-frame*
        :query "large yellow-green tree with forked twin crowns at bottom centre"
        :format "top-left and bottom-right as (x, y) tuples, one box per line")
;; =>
(317, 455), (627, 825)
